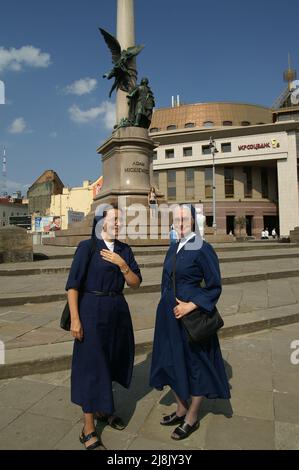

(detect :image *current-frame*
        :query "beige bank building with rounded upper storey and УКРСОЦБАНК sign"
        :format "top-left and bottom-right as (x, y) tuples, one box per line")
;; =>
(150, 103), (299, 238)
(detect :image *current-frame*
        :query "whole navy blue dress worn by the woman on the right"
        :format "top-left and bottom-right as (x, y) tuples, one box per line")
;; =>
(150, 235), (230, 400)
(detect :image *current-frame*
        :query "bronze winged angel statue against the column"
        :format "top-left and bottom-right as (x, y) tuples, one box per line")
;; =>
(99, 28), (144, 98)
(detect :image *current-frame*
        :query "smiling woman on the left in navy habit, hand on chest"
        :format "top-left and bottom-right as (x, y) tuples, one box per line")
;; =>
(65, 204), (142, 450)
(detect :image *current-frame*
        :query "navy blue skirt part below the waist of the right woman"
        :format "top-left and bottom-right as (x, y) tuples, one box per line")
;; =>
(150, 289), (230, 400)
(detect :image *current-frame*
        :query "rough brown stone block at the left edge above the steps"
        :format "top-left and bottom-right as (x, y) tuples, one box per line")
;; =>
(0, 225), (33, 263)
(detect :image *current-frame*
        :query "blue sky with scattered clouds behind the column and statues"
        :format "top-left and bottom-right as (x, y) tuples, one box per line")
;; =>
(0, 0), (299, 195)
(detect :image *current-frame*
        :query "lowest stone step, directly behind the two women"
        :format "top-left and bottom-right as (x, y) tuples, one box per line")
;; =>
(0, 303), (299, 380)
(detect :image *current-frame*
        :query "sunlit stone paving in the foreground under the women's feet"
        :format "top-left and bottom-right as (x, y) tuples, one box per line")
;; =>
(0, 323), (299, 451)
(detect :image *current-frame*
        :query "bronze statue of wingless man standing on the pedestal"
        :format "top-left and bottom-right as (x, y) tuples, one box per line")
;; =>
(127, 78), (155, 129)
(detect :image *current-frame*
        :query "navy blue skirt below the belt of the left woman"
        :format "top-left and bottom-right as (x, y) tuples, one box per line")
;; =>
(71, 292), (135, 415)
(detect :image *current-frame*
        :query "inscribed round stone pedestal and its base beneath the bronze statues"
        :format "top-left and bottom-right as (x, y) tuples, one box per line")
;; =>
(44, 127), (171, 246)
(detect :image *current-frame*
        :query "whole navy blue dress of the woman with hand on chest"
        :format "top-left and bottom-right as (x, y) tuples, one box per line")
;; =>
(65, 239), (142, 415)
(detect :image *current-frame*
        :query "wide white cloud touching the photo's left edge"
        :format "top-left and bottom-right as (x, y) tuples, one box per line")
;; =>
(0, 46), (51, 72)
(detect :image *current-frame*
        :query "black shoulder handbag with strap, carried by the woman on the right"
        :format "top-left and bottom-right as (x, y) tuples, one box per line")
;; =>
(172, 248), (224, 343)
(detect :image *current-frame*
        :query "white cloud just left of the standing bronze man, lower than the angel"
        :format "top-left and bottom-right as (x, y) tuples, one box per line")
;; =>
(69, 101), (116, 129)
